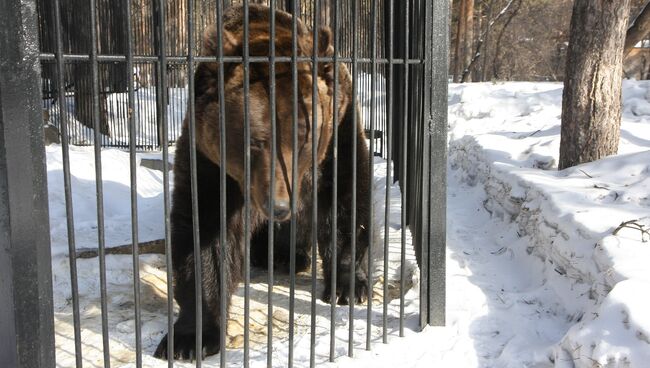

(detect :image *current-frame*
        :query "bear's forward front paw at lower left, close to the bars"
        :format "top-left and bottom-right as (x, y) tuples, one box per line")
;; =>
(153, 331), (220, 361)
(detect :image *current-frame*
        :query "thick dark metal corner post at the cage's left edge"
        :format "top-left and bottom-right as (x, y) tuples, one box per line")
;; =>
(0, 0), (55, 368)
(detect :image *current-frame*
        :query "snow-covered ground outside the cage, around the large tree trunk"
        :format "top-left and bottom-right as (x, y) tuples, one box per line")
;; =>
(345, 81), (650, 368)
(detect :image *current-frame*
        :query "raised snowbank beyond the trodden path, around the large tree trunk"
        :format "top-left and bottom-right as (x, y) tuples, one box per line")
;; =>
(449, 81), (650, 367)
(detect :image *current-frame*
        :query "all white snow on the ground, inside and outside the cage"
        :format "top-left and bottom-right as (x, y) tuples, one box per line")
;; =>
(47, 81), (650, 368)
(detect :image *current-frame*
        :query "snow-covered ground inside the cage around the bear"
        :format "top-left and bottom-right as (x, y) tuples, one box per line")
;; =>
(47, 145), (419, 367)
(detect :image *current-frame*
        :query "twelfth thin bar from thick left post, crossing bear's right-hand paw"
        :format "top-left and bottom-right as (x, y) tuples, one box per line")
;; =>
(348, 1), (359, 357)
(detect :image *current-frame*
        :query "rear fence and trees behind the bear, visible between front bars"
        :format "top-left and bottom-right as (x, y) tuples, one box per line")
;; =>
(37, 0), (390, 155)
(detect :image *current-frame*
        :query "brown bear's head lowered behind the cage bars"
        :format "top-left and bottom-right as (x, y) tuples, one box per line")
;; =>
(195, 5), (351, 221)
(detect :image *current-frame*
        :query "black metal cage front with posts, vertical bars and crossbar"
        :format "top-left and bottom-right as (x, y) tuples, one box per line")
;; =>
(0, 0), (449, 367)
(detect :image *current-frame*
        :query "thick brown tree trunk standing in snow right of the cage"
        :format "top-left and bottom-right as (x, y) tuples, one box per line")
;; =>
(559, 0), (630, 170)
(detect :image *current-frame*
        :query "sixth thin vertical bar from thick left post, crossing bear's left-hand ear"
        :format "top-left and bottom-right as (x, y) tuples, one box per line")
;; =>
(217, 1), (228, 368)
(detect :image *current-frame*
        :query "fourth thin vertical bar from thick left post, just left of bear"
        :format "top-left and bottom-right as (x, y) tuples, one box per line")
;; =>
(156, 0), (174, 368)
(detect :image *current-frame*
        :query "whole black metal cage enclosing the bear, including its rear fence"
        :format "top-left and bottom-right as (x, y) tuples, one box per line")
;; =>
(0, 0), (449, 367)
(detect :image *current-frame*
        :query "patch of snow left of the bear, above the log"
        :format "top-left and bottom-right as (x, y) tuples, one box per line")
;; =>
(46, 145), (171, 256)
